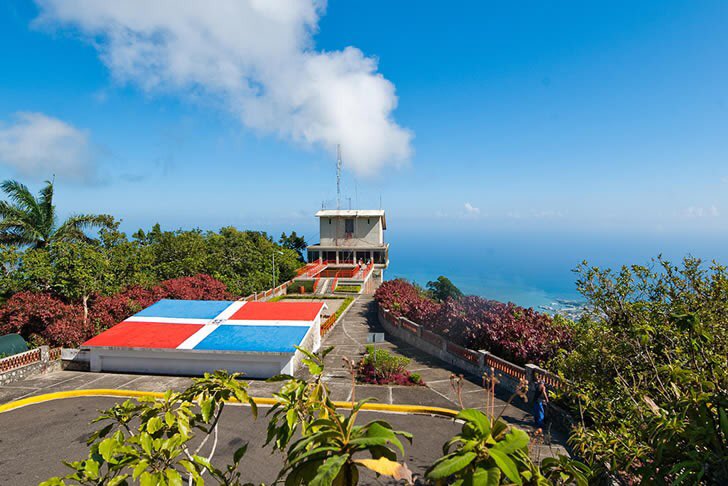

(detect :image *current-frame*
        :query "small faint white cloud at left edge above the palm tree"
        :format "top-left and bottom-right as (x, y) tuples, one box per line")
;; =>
(0, 112), (94, 180)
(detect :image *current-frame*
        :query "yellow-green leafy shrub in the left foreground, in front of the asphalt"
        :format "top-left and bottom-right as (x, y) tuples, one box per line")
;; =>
(41, 371), (256, 486)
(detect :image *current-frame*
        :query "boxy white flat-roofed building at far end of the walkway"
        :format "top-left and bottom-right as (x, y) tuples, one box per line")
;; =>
(308, 209), (389, 285)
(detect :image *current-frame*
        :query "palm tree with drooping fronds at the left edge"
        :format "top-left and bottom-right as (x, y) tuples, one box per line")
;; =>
(0, 180), (114, 248)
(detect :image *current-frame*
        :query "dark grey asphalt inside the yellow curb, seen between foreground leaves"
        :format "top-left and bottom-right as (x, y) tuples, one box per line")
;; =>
(0, 397), (460, 486)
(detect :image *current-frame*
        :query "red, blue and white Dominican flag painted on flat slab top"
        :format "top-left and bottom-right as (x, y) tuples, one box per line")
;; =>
(81, 299), (325, 353)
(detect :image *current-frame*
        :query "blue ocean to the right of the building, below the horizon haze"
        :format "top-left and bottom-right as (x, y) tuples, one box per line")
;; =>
(385, 228), (728, 308)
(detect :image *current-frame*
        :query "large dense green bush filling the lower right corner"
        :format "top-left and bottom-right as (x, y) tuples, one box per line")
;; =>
(554, 258), (728, 484)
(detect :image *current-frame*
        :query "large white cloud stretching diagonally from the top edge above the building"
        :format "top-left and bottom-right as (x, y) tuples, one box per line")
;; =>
(37, 0), (412, 175)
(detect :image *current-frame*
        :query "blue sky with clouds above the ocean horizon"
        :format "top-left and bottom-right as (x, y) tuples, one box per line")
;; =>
(0, 0), (728, 242)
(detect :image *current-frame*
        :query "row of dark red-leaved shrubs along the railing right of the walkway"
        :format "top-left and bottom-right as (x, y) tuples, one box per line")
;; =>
(375, 280), (572, 364)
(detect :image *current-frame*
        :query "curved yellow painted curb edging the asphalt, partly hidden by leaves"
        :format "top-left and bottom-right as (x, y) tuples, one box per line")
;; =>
(0, 388), (458, 417)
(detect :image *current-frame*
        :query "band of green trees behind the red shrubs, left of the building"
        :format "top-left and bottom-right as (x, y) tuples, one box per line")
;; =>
(0, 223), (301, 303)
